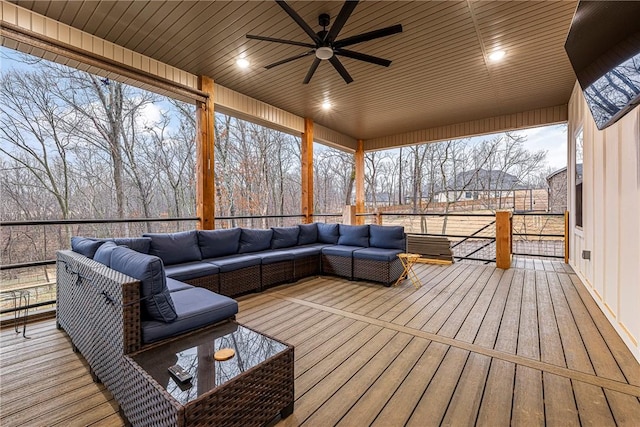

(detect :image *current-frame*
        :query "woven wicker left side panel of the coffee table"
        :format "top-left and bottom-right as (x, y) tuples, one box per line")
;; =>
(120, 357), (185, 427)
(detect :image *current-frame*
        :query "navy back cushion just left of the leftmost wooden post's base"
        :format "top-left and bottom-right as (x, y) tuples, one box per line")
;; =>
(143, 230), (202, 265)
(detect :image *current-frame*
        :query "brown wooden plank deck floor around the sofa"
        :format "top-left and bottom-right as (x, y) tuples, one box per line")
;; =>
(0, 260), (640, 426)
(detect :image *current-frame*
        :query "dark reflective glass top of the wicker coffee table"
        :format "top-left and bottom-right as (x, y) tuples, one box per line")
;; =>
(131, 323), (287, 405)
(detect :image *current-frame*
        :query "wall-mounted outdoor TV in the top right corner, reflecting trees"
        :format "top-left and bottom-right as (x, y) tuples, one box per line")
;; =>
(564, 1), (640, 129)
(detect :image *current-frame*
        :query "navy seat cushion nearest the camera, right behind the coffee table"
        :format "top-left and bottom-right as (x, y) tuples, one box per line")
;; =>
(142, 287), (238, 343)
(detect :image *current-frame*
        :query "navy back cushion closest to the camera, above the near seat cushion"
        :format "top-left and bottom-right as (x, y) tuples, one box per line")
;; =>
(111, 246), (178, 322)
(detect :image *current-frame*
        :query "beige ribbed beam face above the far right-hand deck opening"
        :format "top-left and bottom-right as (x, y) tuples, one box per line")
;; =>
(364, 105), (568, 150)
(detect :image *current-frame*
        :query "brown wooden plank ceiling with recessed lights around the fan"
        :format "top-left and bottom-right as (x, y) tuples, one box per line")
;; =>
(14, 1), (577, 139)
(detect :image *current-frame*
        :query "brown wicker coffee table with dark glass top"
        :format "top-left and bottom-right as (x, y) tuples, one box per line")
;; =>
(119, 322), (294, 426)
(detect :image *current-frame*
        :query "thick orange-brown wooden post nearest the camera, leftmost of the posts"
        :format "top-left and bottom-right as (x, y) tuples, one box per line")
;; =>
(196, 76), (215, 230)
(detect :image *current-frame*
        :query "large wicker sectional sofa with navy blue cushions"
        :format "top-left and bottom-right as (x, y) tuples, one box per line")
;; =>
(57, 223), (406, 408)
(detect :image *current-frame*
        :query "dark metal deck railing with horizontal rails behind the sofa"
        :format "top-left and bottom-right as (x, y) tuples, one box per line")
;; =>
(0, 212), (566, 314)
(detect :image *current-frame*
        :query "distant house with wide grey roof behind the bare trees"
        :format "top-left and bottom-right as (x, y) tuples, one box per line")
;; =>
(434, 169), (525, 202)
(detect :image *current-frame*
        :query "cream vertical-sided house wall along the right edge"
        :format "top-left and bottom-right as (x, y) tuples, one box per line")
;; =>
(567, 84), (640, 361)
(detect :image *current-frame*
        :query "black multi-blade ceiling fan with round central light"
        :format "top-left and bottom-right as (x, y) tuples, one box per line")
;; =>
(247, 0), (402, 84)
